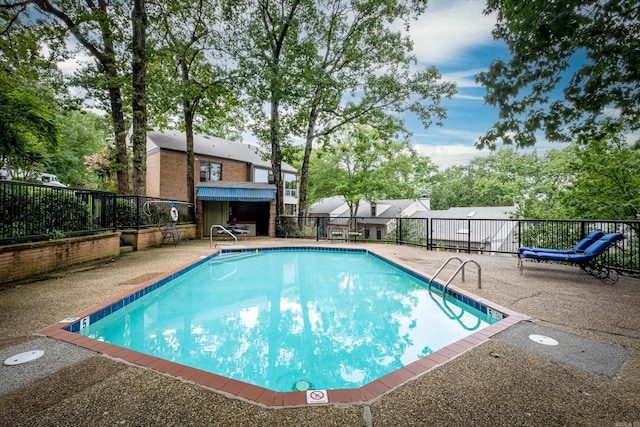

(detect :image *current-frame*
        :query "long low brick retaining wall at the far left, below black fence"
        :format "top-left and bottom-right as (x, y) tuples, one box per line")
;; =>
(0, 233), (120, 283)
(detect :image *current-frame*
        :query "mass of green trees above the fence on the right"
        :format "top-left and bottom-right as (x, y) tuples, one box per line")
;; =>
(431, 133), (640, 220)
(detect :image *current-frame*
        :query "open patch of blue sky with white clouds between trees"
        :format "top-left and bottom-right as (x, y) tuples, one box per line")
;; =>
(407, 0), (509, 169)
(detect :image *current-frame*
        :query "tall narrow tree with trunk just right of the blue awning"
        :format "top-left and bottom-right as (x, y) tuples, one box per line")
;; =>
(227, 0), (317, 216)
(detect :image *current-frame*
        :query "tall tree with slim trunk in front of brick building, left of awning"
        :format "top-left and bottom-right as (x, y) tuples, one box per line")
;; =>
(151, 1), (237, 203)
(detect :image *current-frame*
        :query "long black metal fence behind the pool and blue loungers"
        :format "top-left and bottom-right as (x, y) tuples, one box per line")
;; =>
(276, 217), (640, 275)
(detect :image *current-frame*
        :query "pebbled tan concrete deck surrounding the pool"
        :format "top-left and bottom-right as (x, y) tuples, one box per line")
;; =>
(0, 239), (640, 427)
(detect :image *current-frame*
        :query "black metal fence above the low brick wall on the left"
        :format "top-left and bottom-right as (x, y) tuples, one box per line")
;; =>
(0, 181), (195, 244)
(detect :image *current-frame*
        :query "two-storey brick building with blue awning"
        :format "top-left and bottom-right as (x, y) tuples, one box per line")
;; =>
(146, 130), (298, 237)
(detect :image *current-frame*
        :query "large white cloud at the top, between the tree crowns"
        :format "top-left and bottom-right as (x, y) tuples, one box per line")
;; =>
(411, 0), (495, 64)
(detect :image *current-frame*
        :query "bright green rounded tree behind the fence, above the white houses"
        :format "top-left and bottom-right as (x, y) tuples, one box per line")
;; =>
(311, 125), (436, 218)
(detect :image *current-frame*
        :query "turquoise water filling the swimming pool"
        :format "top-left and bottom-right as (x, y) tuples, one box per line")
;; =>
(80, 249), (497, 391)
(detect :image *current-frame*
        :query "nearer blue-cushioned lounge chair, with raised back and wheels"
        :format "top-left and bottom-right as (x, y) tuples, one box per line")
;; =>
(518, 233), (624, 282)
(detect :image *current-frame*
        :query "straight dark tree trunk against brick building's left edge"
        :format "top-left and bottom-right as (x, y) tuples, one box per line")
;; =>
(131, 0), (147, 195)
